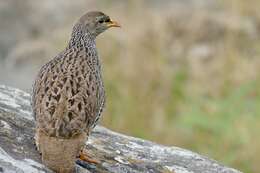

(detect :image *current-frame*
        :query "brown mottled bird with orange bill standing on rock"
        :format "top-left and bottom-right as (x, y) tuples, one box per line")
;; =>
(31, 11), (120, 173)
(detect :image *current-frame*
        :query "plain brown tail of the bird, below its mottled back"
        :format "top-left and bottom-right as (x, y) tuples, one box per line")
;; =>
(36, 130), (86, 173)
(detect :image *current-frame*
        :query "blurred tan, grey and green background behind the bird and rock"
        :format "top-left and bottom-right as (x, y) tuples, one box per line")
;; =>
(0, 0), (260, 173)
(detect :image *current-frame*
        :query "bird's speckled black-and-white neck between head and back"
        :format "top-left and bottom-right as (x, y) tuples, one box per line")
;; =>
(67, 24), (96, 49)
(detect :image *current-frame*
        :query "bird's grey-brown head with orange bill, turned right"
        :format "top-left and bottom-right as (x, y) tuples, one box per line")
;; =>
(78, 11), (120, 37)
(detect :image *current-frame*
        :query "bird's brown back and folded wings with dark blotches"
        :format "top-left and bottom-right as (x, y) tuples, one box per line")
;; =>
(32, 47), (105, 138)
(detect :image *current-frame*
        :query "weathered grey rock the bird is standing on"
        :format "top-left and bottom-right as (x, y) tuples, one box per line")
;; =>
(0, 86), (240, 173)
